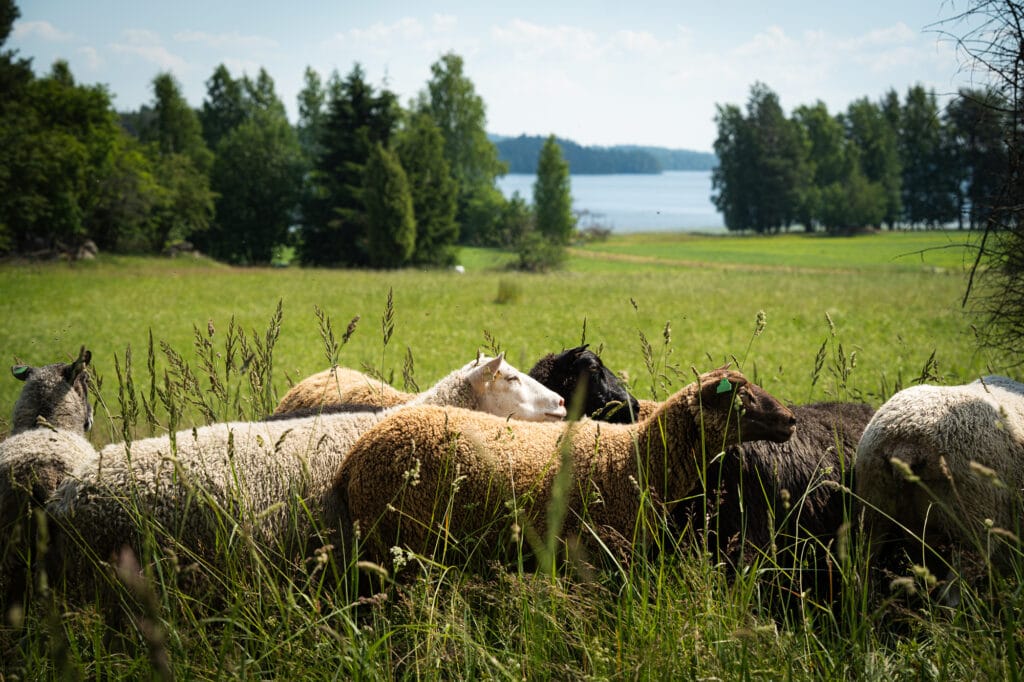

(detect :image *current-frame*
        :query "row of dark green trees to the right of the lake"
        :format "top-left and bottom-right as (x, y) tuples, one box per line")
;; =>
(712, 83), (1010, 232)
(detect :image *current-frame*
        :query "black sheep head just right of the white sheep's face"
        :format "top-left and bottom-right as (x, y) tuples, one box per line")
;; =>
(530, 345), (640, 424)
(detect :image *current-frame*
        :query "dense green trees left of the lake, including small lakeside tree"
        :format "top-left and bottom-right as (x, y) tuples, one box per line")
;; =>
(0, 0), (574, 268)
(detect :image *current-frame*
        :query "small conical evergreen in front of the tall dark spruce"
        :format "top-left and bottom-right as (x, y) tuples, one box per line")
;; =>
(362, 142), (416, 267)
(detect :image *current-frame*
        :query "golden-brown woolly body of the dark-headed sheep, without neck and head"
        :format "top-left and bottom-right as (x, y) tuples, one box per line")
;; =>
(332, 407), (655, 562)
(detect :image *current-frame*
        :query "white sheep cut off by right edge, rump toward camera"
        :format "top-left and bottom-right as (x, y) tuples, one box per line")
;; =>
(854, 376), (1024, 577)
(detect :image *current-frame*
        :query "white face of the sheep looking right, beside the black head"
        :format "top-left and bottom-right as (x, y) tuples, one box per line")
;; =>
(466, 353), (565, 422)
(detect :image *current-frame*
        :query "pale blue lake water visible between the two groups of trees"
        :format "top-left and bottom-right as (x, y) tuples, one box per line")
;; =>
(498, 171), (725, 232)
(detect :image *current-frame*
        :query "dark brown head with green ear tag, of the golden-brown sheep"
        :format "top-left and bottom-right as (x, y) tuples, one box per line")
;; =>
(697, 368), (797, 444)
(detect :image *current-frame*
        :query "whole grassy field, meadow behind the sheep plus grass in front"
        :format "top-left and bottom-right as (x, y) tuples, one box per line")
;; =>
(0, 231), (1024, 680)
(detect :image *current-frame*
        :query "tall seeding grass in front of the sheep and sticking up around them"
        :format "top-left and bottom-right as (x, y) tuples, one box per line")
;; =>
(0, 297), (1024, 680)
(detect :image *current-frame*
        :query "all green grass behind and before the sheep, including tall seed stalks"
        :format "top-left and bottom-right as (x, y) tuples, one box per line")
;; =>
(0, 232), (1024, 680)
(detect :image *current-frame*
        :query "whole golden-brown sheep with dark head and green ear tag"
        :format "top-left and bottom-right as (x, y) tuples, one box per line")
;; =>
(328, 368), (794, 567)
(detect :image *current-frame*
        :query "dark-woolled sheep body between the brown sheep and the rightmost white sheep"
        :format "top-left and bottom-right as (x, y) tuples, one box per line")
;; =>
(673, 402), (874, 602)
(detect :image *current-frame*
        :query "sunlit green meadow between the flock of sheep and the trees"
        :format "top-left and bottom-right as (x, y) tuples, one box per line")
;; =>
(0, 228), (1007, 438)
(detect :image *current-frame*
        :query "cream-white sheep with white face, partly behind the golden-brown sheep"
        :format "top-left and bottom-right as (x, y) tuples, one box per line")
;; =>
(47, 357), (565, 573)
